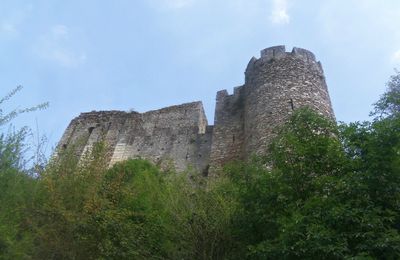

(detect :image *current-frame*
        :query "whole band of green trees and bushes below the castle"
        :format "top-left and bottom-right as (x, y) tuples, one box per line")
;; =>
(0, 72), (400, 259)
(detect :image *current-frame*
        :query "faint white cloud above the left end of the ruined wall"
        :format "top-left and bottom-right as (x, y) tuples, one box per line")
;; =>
(34, 24), (87, 68)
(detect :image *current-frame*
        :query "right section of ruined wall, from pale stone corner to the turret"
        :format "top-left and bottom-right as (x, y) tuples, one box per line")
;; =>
(110, 102), (211, 171)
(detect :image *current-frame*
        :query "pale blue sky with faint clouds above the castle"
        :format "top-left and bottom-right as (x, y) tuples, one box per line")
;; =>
(0, 0), (400, 153)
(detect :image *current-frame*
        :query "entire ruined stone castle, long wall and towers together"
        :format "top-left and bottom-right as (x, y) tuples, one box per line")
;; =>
(59, 46), (334, 174)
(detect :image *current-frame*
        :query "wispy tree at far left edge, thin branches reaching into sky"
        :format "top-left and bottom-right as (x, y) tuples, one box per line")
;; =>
(0, 86), (47, 259)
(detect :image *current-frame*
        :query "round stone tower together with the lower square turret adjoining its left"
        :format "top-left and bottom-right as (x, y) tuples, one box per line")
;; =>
(210, 46), (334, 168)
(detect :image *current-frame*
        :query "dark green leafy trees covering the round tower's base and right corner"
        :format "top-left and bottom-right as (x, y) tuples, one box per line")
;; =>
(228, 106), (400, 259)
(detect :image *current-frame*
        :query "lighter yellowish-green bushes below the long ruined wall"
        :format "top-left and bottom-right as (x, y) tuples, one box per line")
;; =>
(30, 143), (238, 259)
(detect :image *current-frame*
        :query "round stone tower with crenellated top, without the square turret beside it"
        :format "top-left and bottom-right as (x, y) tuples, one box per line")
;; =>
(244, 46), (334, 157)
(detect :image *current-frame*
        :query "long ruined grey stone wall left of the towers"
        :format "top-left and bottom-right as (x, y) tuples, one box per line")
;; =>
(60, 102), (212, 171)
